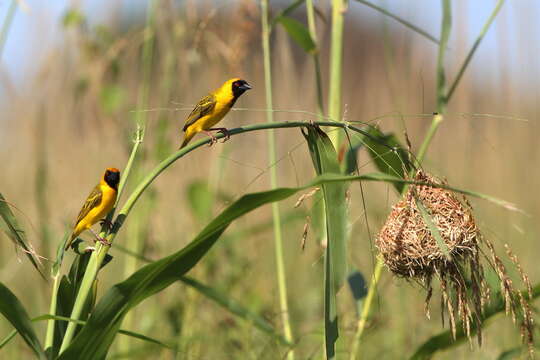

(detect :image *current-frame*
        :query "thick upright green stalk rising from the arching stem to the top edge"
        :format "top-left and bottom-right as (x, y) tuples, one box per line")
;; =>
(328, 0), (347, 149)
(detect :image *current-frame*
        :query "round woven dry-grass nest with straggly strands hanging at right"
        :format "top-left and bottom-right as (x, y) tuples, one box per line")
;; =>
(376, 171), (533, 351)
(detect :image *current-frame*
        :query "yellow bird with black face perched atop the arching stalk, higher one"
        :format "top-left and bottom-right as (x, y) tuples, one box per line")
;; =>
(180, 78), (251, 149)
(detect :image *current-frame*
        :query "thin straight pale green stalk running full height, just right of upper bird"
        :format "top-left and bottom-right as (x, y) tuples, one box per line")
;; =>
(261, 0), (294, 360)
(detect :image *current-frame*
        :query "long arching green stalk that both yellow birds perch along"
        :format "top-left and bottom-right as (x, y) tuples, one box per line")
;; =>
(60, 121), (369, 353)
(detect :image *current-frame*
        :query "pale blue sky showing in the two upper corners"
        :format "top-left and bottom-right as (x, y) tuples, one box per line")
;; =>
(0, 0), (540, 88)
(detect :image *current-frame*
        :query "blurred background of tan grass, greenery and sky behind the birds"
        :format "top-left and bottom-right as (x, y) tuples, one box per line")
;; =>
(0, 0), (540, 359)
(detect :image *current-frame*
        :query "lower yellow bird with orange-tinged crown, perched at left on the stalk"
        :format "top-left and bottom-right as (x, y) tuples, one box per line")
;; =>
(66, 168), (120, 250)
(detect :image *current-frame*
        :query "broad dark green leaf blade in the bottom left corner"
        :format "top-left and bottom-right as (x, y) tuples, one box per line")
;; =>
(0, 283), (46, 359)
